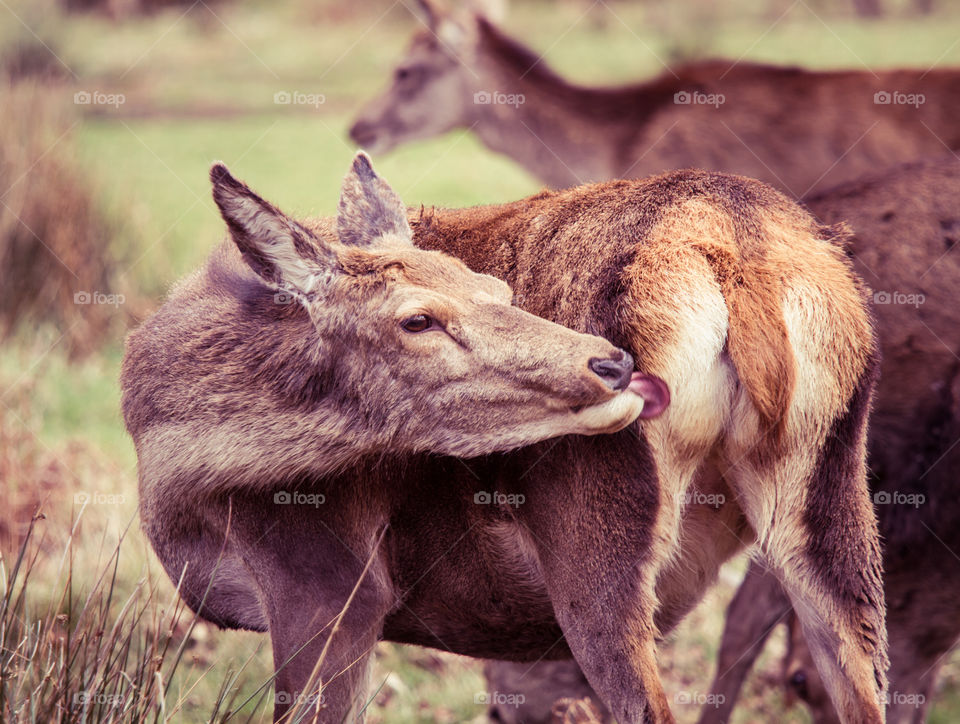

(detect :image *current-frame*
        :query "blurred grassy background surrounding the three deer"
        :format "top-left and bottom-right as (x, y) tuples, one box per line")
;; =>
(0, 0), (960, 723)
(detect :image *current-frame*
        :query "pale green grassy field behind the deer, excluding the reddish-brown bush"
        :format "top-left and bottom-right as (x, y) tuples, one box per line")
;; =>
(0, 0), (960, 723)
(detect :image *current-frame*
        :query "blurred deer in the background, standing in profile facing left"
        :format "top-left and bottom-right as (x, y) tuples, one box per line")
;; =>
(349, 0), (960, 199)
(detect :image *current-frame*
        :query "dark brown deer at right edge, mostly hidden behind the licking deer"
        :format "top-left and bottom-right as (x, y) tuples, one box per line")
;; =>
(692, 155), (960, 724)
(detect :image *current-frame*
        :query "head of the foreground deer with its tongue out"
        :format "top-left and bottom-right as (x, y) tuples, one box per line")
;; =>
(211, 153), (667, 472)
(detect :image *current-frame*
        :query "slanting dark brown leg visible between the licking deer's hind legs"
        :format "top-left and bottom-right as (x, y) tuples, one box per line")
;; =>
(698, 561), (790, 724)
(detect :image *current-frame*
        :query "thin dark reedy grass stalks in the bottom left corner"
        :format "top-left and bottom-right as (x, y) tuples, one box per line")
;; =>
(0, 507), (278, 722)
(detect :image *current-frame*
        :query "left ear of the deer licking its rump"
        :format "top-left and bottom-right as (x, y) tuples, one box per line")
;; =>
(210, 163), (336, 294)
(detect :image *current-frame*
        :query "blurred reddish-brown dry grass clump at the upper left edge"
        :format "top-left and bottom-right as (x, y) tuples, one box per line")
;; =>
(0, 81), (123, 355)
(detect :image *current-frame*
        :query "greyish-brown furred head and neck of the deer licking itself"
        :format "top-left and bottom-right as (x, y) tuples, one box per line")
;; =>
(125, 160), (648, 504)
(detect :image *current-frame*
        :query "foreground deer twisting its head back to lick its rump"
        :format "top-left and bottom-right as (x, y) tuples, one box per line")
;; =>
(121, 155), (887, 722)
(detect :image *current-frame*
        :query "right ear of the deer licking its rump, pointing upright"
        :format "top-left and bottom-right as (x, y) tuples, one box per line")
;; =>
(337, 151), (413, 246)
